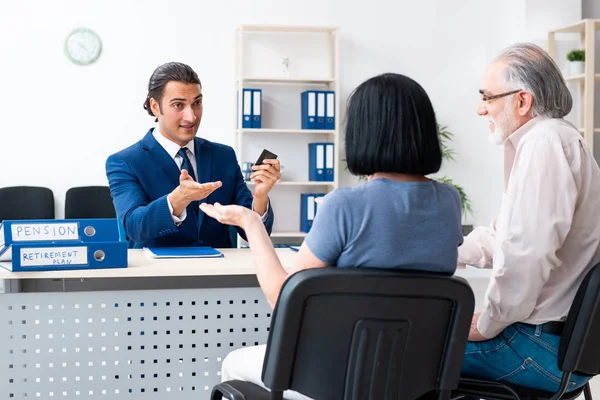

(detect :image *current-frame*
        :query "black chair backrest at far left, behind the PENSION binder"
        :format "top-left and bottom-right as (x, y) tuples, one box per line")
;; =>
(0, 186), (54, 221)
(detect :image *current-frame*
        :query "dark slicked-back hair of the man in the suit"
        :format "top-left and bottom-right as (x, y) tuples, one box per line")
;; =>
(144, 62), (202, 121)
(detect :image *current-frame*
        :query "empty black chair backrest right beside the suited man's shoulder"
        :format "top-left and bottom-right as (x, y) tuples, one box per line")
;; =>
(65, 186), (117, 219)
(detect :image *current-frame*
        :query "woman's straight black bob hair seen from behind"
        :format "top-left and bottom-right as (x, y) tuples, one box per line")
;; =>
(346, 73), (442, 175)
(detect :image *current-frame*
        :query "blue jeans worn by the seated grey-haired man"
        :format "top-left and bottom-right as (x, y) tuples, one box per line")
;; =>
(461, 323), (591, 392)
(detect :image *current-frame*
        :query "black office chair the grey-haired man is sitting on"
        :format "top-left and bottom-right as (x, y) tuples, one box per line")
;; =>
(453, 264), (600, 400)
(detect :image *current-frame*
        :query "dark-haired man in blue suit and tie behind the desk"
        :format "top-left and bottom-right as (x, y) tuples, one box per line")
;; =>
(106, 63), (281, 248)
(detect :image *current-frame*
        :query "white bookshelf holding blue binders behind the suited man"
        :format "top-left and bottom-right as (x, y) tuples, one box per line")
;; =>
(235, 25), (340, 246)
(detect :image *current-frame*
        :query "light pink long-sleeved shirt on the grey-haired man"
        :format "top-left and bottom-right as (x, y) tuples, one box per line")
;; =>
(458, 117), (600, 338)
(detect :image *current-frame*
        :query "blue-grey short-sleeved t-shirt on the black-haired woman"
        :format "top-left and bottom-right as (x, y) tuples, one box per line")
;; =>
(306, 178), (463, 274)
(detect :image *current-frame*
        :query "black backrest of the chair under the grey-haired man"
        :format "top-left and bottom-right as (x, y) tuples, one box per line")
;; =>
(558, 264), (600, 375)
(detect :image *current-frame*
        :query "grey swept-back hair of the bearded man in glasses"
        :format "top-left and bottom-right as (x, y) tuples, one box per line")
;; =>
(494, 43), (573, 118)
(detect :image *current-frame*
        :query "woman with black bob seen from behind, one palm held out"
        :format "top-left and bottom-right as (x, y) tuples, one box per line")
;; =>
(200, 73), (463, 399)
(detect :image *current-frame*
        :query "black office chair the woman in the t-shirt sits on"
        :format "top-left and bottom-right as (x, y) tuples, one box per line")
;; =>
(212, 268), (474, 400)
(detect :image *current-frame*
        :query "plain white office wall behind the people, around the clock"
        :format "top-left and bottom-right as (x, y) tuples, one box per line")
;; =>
(0, 0), (581, 225)
